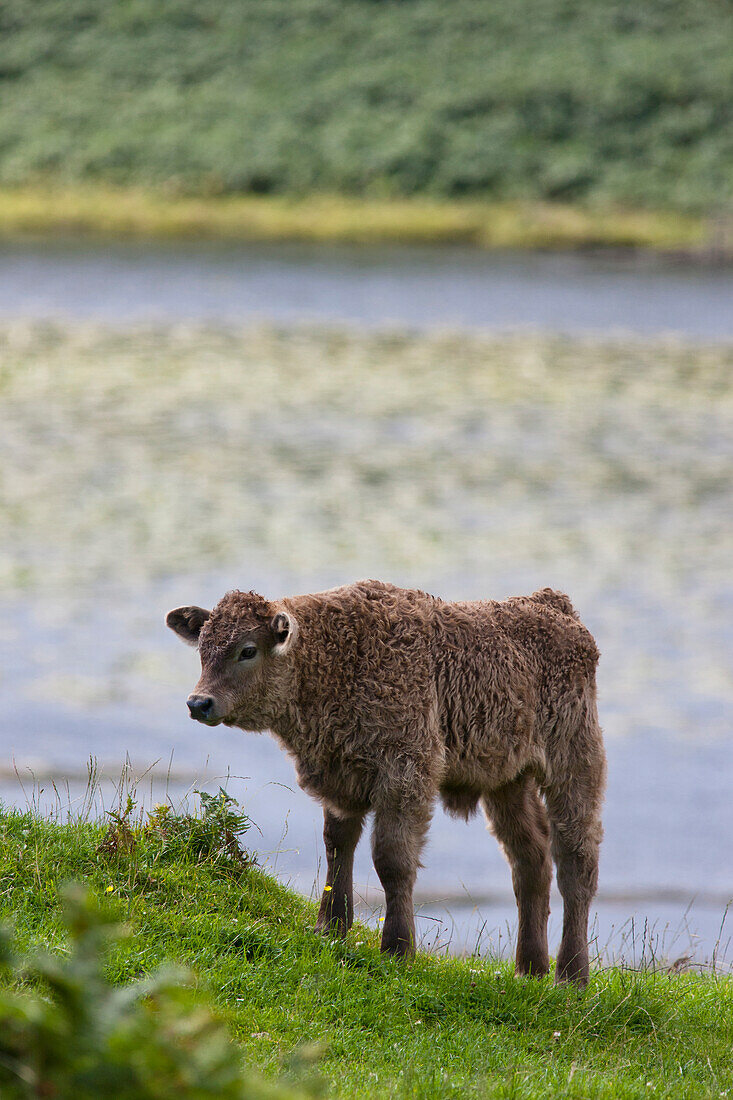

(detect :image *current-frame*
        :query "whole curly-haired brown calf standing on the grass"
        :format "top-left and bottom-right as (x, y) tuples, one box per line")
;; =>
(166, 581), (605, 985)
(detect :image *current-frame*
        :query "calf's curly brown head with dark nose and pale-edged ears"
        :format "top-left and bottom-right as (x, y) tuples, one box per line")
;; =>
(165, 592), (298, 729)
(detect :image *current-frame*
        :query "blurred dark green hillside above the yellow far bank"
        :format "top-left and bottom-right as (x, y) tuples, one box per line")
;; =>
(0, 0), (733, 210)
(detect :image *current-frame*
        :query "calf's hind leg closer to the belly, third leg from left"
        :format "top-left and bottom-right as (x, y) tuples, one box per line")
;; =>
(482, 774), (553, 978)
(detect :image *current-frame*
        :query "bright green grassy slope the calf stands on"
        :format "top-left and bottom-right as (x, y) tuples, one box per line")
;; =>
(0, 813), (733, 1098)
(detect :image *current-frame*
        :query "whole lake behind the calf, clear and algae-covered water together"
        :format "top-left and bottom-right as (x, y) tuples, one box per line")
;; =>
(0, 245), (733, 961)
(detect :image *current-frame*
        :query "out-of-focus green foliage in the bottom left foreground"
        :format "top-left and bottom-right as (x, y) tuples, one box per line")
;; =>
(0, 888), (303, 1100)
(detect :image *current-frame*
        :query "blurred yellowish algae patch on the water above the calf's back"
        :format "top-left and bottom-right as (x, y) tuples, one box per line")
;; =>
(0, 323), (733, 594)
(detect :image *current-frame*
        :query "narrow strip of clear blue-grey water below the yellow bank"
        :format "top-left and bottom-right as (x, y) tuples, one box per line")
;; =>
(0, 243), (733, 340)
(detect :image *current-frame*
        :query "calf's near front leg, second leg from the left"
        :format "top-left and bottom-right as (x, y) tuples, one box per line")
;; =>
(372, 807), (431, 955)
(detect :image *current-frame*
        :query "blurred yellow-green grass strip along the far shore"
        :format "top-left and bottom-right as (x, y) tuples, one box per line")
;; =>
(0, 184), (708, 256)
